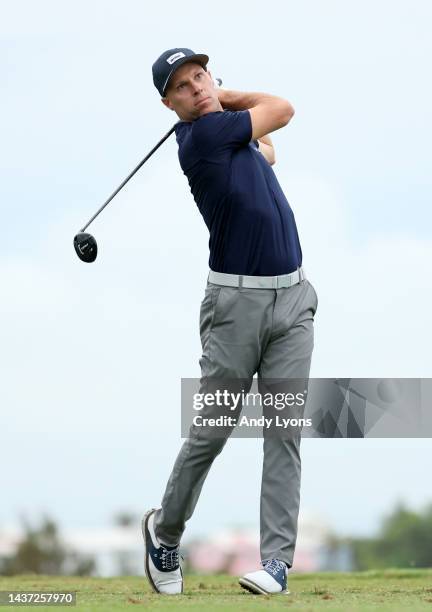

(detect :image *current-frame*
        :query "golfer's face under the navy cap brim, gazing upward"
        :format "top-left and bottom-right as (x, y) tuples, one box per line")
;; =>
(162, 62), (223, 121)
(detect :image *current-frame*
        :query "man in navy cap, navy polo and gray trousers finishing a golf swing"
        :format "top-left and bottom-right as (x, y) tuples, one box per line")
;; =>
(143, 48), (318, 594)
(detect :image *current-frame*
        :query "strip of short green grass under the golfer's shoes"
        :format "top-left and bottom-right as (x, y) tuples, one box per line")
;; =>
(0, 569), (432, 612)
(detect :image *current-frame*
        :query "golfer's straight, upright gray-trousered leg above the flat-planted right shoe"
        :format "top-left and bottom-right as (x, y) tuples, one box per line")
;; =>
(258, 280), (317, 567)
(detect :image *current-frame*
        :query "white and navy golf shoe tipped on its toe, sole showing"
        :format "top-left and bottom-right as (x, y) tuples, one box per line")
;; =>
(141, 508), (183, 595)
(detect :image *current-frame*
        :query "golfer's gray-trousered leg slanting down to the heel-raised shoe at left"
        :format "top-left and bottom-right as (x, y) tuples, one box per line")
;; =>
(154, 283), (273, 546)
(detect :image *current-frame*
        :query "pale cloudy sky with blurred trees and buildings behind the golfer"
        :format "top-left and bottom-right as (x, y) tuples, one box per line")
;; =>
(0, 0), (432, 575)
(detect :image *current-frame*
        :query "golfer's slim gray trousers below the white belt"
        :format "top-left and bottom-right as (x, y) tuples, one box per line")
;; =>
(154, 279), (318, 567)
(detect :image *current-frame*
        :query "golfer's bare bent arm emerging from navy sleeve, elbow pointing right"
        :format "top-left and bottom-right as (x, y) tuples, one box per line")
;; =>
(217, 89), (294, 140)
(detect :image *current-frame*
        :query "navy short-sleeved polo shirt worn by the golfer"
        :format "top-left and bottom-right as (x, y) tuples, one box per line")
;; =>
(175, 110), (302, 276)
